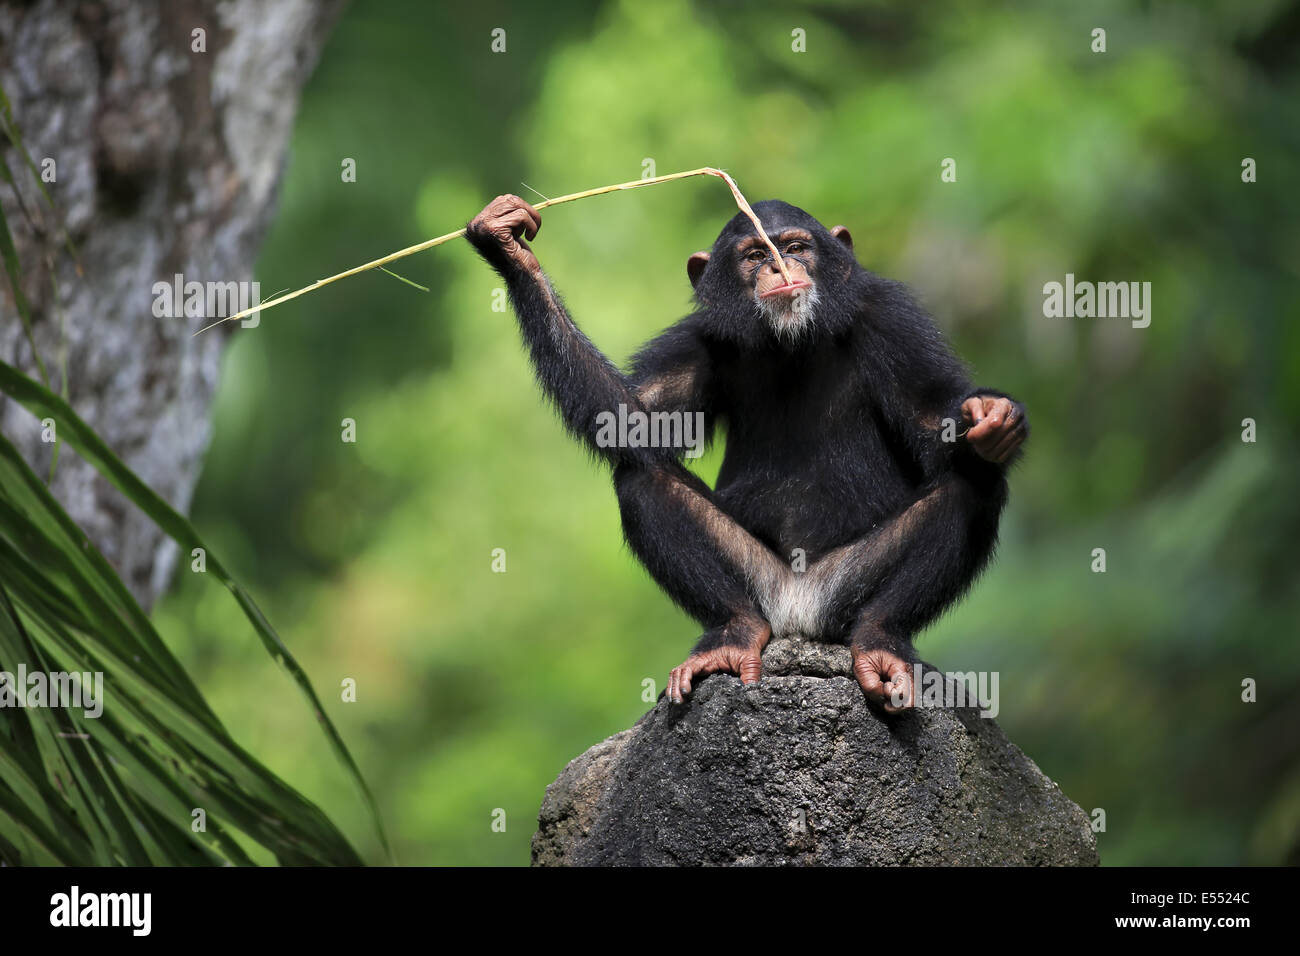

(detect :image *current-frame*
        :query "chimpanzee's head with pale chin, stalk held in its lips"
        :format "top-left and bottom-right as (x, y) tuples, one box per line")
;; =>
(686, 199), (862, 343)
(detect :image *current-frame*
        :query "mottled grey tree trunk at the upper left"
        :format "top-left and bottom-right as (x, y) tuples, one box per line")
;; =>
(0, 0), (342, 607)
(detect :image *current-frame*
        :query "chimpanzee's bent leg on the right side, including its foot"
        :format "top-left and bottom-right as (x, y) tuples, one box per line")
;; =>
(810, 475), (1006, 711)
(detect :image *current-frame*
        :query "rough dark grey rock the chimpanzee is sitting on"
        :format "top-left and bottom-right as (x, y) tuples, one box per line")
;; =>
(533, 640), (1099, 866)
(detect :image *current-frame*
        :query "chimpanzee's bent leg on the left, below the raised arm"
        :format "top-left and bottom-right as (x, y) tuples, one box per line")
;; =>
(614, 463), (789, 702)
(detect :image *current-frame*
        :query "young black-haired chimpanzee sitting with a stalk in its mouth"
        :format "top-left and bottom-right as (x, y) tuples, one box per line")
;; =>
(468, 195), (1028, 711)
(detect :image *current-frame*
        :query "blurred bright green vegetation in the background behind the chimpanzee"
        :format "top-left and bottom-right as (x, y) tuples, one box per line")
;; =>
(147, 0), (1300, 865)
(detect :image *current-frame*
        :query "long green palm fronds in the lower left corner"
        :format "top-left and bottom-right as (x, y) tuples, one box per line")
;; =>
(0, 362), (379, 866)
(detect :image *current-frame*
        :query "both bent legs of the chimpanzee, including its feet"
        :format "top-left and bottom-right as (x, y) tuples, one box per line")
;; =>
(615, 463), (1006, 710)
